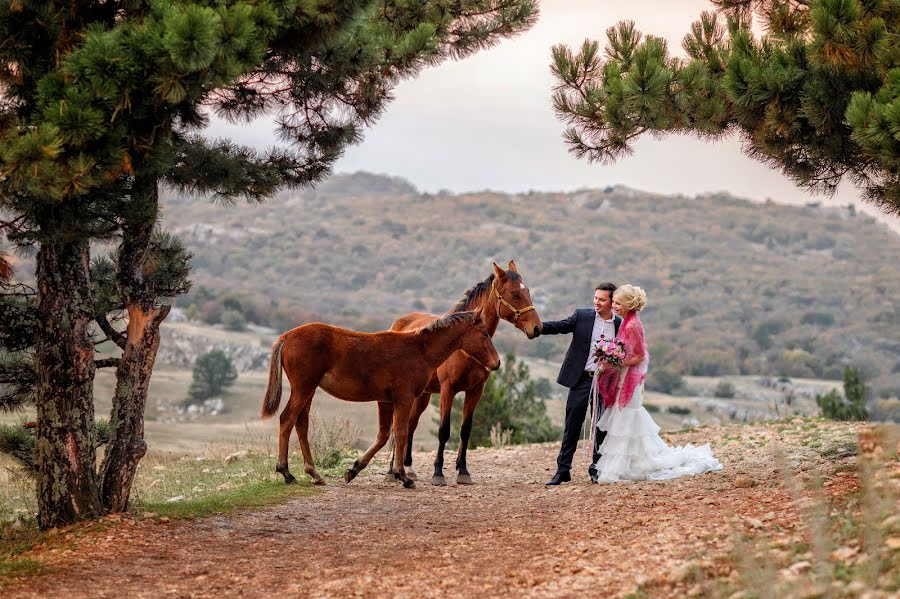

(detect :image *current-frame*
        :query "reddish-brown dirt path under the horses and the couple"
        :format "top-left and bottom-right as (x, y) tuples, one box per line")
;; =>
(4, 425), (864, 598)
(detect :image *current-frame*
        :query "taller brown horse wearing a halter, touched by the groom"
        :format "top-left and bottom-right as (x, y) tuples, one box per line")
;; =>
(388, 260), (541, 486)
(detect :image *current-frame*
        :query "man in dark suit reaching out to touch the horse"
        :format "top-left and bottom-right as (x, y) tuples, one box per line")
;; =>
(540, 283), (622, 485)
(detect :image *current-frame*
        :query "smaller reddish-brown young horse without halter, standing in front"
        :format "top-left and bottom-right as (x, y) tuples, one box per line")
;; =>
(262, 310), (500, 488)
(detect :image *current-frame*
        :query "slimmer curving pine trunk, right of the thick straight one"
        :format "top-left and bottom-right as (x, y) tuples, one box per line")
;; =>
(100, 174), (171, 512)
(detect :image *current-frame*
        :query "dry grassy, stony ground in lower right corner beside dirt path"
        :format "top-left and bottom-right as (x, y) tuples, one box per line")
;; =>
(629, 420), (900, 599)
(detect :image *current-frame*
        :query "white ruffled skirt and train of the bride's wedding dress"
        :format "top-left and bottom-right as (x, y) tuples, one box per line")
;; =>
(595, 372), (722, 482)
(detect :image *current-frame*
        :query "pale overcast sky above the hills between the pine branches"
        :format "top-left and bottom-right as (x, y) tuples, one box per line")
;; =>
(211, 0), (897, 230)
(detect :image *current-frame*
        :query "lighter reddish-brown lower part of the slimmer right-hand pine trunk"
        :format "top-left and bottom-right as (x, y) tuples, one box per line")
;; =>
(100, 305), (170, 512)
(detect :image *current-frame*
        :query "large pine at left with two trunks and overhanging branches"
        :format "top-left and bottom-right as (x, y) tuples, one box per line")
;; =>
(0, 0), (536, 528)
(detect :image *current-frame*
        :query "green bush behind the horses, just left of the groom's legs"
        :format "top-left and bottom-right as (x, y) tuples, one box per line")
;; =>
(432, 353), (560, 448)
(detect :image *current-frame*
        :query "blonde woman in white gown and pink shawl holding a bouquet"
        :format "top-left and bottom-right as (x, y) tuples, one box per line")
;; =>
(593, 285), (722, 482)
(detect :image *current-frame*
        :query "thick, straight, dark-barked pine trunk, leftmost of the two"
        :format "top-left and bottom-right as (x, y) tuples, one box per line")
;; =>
(34, 241), (102, 529)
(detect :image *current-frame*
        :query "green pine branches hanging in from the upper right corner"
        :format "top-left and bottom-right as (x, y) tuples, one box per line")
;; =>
(551, 0), (900, 214)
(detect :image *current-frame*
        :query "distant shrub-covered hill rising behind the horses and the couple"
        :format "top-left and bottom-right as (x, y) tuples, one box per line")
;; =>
(164, 173), (900, 395)
